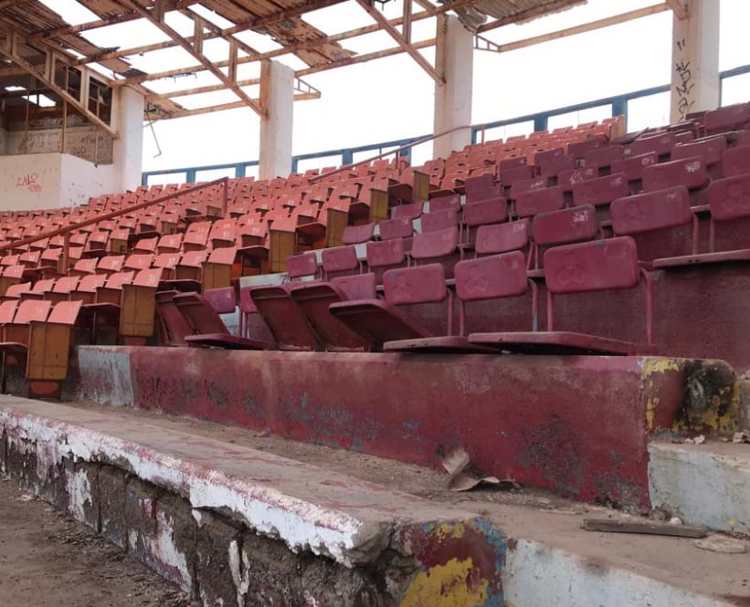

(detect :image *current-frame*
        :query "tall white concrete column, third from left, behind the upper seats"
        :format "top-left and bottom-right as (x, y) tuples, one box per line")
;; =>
(432, 15), (474, 158)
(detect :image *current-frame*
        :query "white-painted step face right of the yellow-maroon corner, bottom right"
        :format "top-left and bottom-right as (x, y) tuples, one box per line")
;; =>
(503, 540), (737, 607)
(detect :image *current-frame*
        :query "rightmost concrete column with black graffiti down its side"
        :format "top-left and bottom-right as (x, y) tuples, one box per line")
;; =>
(670, 0), (721, 122)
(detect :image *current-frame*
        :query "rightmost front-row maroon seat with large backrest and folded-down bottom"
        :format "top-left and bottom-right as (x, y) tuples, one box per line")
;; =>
(469, 236), (652, 355)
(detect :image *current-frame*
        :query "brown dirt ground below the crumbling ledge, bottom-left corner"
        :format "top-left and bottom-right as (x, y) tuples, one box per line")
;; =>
(0, 479), (191, 607)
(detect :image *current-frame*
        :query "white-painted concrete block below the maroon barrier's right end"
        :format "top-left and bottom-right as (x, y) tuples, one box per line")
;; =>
(649, 442), (750, 535)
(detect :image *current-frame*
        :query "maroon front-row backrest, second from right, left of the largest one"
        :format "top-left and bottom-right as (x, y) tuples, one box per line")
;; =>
(454, 251), (528, 301)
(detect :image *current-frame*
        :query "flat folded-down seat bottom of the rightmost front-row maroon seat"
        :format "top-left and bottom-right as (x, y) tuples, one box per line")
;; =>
(468, 331), (653, 356)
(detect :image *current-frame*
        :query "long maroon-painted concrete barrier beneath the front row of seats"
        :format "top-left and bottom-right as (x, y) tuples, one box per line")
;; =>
(75, 346), (738, 510)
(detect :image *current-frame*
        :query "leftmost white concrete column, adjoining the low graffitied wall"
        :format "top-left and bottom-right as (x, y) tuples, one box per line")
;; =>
(112, 86), (145, 191)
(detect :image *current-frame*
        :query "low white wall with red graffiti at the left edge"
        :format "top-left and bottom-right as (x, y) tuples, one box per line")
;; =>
(0, 153), (116, 211)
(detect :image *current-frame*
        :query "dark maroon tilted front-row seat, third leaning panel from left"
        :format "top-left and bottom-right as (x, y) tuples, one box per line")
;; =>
(249, 285), (318, 351)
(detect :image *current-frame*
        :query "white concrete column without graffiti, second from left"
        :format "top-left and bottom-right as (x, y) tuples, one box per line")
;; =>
(258, 61), (294, 179)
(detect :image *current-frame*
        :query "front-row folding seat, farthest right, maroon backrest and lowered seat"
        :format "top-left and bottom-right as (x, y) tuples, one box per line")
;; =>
(469, 236), (653, 355)
